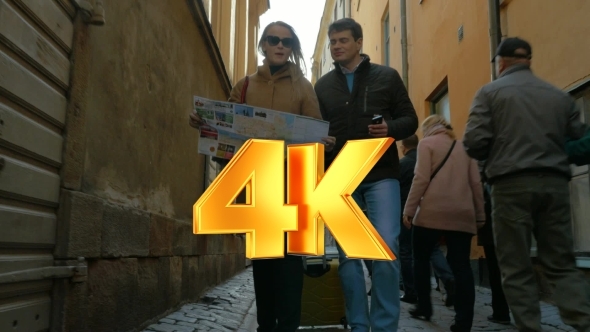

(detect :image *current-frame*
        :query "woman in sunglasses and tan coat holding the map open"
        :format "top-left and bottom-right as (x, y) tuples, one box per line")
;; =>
(190, 21), (336, 332)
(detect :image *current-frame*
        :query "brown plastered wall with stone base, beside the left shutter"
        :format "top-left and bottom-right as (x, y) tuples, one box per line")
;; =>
(53, 0), (264, 332)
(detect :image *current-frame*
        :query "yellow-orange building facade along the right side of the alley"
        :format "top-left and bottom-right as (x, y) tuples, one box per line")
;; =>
(312, 0), (590, 268)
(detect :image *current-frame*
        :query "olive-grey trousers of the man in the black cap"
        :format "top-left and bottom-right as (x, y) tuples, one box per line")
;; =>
(492, 173), (590, 332)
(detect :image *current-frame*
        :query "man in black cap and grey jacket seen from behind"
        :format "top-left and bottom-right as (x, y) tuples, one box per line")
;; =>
(463, 38), (590, 332)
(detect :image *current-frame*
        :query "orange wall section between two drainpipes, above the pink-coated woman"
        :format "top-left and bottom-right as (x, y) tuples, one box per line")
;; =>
(407, 0), (491, 137)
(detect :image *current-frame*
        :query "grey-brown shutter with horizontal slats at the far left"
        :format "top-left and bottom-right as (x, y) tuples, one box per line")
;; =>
(0, 0), (73, 331)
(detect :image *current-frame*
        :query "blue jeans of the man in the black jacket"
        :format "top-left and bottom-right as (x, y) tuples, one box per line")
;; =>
(337, 179), (401, 332)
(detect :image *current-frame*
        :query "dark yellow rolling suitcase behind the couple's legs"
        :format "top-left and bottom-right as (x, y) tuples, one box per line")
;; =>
(300, 247), (348, 328)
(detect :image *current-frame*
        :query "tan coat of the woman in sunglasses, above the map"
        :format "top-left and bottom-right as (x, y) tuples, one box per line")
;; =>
(229, 60), (322, 119)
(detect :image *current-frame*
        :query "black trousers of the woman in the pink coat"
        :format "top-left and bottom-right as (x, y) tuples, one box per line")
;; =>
(412, 226), (475, 329)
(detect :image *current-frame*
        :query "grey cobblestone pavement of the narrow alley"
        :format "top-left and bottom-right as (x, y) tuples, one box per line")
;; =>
(143, 268), (575, 332)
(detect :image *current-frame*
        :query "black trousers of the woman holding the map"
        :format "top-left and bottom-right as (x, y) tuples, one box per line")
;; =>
(252, 250), (303, 332)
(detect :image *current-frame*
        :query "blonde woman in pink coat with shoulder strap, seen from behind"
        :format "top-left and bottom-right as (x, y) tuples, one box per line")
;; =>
(404, 115), (485, 332)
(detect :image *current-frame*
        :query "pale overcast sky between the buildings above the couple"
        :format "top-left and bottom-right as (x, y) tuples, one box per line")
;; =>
(258, 0), (325, 79)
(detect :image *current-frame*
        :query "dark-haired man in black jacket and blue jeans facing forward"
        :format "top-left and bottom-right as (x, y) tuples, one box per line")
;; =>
(315, 18), (418, 332)
